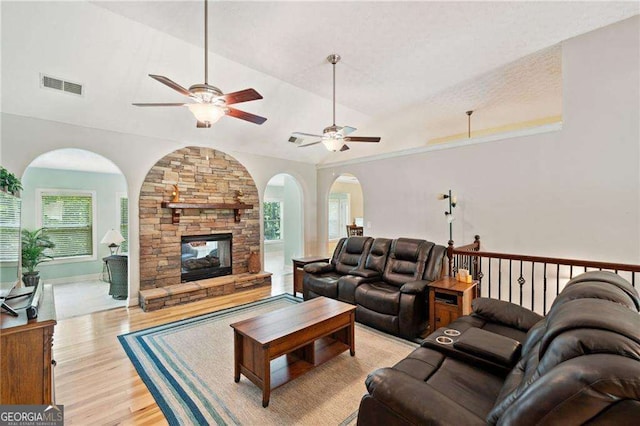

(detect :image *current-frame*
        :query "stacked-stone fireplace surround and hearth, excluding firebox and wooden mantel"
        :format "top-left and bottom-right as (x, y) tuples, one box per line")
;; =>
(139, 147), (271, 310)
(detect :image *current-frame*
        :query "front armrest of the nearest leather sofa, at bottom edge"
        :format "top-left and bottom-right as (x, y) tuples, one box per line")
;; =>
(365, 368), (486, 425)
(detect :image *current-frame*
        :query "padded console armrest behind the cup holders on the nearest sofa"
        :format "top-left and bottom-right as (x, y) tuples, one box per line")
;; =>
(453, 328), (522, 367)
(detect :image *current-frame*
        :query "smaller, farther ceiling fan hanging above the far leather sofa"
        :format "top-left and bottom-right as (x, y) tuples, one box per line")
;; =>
(289, 53), (380, 152)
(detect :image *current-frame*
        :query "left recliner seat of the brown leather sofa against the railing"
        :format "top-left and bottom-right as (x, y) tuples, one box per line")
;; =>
(302, 237), (373, 300)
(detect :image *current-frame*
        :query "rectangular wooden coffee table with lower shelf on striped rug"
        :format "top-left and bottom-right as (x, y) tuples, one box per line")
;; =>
(231, 297), (356, 407)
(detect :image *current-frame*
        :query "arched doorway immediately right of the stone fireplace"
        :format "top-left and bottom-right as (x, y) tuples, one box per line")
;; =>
(262, 173), (304, 280)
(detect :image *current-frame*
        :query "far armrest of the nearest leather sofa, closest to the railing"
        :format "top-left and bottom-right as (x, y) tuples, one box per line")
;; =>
(471, 297), (543, 331)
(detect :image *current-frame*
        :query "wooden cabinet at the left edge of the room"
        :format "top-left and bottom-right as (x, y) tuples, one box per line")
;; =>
(0, 285), (56, 405)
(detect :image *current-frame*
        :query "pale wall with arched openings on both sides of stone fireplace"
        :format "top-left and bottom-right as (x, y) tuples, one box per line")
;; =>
(1, 113), (317, 305)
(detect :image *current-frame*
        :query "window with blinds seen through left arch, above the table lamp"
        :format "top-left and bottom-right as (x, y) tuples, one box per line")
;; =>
(38, 190), (95, 258)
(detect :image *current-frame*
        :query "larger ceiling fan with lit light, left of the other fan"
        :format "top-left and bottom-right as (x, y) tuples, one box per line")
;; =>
(133, 0), (267, 128)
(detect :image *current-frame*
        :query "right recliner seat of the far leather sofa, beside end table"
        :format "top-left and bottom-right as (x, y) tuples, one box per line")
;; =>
(355, 238), (446, 339)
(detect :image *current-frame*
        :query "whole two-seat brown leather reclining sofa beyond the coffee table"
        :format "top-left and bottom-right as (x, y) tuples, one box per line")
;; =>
(302, 237), (446, 339)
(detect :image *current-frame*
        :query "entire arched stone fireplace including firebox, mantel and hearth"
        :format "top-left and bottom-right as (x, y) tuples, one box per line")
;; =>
(139, 147), (271, 309)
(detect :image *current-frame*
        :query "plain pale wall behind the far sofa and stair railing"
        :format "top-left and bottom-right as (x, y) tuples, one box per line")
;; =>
(318, 16), (640, 263)
